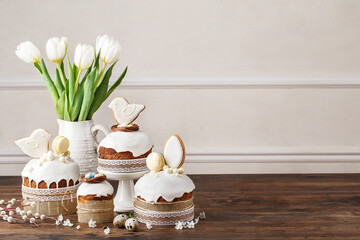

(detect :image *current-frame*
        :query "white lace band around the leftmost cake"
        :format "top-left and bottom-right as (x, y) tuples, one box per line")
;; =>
(22, 184), (80, 201)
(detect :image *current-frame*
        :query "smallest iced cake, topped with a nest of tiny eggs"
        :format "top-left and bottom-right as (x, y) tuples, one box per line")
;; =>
(77, 173), (114, 223)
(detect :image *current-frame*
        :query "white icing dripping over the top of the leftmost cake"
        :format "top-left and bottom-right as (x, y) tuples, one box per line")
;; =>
(21, 154), (80, 187)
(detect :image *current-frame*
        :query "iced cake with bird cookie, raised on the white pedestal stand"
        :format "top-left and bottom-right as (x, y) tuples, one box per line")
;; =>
(98, 97), (154, 173)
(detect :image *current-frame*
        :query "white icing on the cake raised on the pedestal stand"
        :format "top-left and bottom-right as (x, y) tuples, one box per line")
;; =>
(99, 131), (154, 157)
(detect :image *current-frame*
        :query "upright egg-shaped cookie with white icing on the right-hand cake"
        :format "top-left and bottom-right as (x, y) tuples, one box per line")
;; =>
(163, 134), (185, 168)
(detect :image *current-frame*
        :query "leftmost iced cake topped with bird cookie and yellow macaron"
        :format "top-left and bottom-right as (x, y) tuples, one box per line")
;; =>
(15, 129), (80, 216)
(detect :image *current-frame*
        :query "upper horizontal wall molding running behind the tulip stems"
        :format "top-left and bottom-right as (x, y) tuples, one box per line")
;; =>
(0, 73), (360, 90)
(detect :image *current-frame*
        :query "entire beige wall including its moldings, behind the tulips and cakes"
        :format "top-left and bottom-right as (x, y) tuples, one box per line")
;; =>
(0, 0), (360, 175)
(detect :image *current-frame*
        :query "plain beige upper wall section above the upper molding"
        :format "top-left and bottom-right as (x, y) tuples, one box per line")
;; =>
(0, 0), (360, 80)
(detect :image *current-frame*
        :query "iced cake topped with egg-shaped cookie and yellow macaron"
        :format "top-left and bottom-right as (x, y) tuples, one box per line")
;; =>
(134, 135), (195, 225)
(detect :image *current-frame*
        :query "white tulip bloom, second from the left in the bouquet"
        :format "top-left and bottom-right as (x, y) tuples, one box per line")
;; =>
(46, 37), (67, 62)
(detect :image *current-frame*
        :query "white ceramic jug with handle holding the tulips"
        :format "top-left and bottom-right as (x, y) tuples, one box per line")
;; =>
(57, 119), (110, 175)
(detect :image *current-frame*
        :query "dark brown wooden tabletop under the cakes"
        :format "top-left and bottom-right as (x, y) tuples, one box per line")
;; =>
(0, 174), (360, 239)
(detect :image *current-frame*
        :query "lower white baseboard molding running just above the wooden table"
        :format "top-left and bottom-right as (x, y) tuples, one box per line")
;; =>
(0, 149), (360, 176)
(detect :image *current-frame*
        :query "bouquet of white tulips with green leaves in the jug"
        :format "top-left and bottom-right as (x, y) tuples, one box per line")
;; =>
(15, 35), (127, 122)
